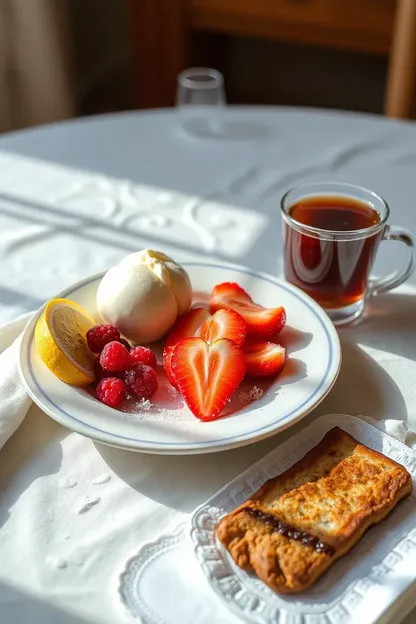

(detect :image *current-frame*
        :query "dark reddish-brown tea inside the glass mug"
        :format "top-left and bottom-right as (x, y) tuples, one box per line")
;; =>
(284, 196), (382, 308)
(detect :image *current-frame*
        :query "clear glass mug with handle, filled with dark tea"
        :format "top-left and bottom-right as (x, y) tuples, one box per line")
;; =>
(281, 182), (415, 325)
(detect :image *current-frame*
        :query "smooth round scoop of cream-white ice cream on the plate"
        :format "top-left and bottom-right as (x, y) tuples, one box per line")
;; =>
(97, 249), (192, 343)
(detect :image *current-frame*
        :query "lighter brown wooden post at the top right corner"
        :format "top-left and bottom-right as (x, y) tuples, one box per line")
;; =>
(384, 0), (416, 119)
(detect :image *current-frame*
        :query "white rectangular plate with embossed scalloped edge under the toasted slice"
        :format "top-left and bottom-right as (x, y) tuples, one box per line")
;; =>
(191, 415), (416, 624)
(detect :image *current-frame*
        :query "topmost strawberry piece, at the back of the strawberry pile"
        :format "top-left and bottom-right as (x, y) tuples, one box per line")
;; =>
(209, 282), (286, 339)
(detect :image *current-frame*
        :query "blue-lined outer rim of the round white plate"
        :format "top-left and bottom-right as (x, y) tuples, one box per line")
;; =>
(19, 262), (341, 452)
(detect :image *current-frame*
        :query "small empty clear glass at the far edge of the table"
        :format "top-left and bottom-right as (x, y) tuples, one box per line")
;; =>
(176, 67), (226, 135)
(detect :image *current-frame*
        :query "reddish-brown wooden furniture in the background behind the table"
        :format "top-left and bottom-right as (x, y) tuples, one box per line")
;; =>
(131, 0), (416, 117)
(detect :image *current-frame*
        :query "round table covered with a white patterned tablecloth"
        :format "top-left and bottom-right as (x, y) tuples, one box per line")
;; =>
(0, 107), (416, 624)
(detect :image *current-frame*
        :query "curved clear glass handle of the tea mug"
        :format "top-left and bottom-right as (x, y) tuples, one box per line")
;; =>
(367, 225), (416, 297)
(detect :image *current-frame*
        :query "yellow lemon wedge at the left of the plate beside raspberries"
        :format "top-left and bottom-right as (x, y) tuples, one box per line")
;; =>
(35, 299), (95, 386)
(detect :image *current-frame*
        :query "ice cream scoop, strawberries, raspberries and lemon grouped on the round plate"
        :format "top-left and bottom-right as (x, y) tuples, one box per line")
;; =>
(35, 249), (286, 421)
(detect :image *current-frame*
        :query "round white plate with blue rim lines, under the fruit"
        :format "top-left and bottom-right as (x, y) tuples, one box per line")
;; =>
(19, 262), (341, 454)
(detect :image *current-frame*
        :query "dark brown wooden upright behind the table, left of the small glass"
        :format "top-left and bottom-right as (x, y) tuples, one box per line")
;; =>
(130, 0), (188, 108)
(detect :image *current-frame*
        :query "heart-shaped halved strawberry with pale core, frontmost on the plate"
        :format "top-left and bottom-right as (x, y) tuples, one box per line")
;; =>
(171, 338), (246, 420)
